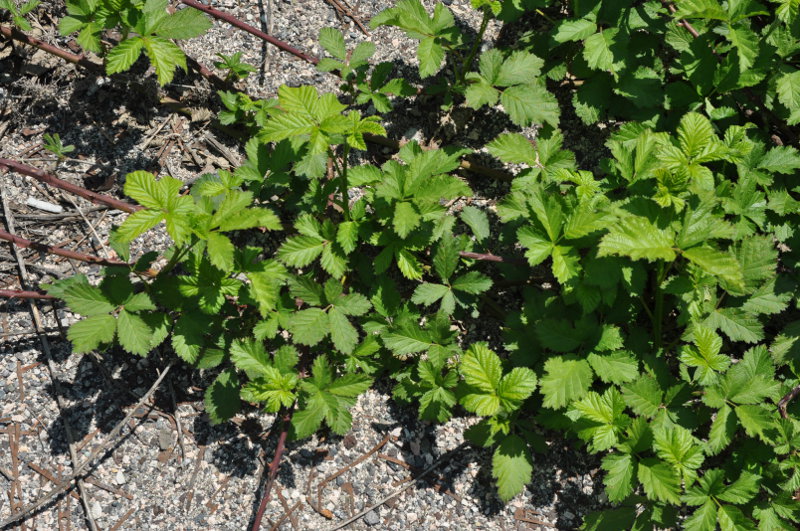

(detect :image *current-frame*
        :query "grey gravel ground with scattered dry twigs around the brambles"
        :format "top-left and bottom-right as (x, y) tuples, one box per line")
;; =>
(0, 0), (604, 530)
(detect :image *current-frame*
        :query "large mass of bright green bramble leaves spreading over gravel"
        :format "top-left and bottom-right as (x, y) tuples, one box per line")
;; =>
(12, 0), (800, 530)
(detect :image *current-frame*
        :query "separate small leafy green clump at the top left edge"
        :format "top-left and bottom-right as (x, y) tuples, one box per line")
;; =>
(59, 0), (211, 85)
